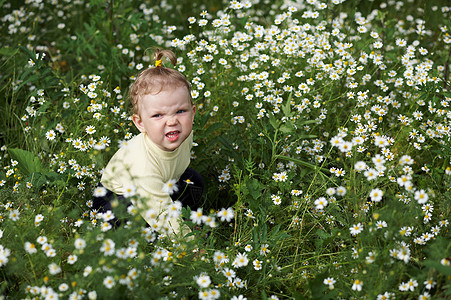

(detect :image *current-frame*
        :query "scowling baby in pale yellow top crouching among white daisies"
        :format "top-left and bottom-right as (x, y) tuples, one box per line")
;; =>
(93, 49), (204, 235)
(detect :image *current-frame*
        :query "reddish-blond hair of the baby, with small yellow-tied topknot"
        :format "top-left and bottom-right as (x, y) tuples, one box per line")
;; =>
(129, 48), (192, 114)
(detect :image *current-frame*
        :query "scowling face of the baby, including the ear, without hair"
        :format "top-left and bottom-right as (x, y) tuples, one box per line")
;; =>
(132, 87), (196, 151)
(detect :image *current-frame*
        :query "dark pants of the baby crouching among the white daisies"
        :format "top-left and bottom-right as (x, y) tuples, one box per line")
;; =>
(91, 168), (204, 228)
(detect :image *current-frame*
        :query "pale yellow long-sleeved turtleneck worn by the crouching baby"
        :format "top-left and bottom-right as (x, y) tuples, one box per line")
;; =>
(100, 132), (193, 235)
